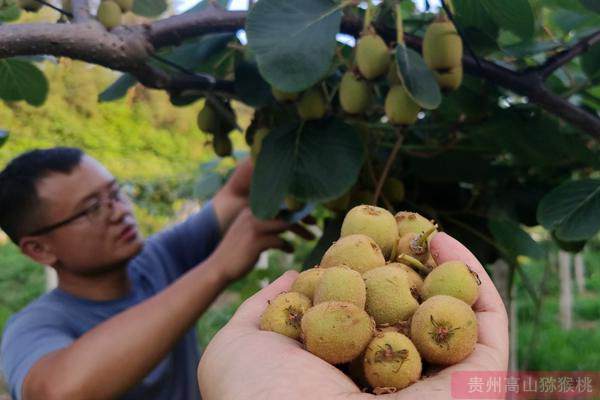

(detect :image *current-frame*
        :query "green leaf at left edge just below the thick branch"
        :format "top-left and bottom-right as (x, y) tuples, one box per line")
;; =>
(0, 59), (48, 106)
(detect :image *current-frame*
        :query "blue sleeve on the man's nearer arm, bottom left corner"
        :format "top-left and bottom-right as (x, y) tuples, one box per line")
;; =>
(0, 310), (75, 400)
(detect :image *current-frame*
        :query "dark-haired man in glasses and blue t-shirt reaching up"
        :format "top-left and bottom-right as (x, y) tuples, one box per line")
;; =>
(0, 148), (309, 400)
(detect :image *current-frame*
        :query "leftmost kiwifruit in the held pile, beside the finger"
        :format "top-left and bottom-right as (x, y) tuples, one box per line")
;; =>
(260, 292), (312, 339)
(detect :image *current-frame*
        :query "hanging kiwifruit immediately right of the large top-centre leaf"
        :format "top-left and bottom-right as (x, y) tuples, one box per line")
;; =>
(355, 34), (390, 79)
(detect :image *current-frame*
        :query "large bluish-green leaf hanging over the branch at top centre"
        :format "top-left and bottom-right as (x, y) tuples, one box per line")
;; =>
(246, 0), (342, 92)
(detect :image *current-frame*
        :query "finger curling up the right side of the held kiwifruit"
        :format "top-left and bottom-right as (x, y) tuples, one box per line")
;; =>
(429, 232), (508, 355)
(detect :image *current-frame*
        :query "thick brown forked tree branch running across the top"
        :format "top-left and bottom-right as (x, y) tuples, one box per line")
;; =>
(0, 8), (600, 137)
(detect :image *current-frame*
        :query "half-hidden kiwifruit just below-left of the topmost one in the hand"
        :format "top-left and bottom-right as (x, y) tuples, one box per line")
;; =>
(320, 235), (385, 274)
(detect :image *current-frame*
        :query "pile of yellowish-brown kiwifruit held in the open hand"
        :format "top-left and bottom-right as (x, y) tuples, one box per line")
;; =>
(260, 205), (481, 394)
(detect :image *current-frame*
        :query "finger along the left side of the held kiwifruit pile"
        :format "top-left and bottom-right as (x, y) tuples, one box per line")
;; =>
(229, 271), (298, 329)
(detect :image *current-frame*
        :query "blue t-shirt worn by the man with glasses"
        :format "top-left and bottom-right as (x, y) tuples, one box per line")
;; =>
(0, 202), (220, 400)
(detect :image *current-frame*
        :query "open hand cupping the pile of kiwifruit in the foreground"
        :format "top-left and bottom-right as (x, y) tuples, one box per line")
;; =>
(198, 232), (508, 400)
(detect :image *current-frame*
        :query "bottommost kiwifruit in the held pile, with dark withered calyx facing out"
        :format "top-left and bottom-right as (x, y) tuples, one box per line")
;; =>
(363, 332), (423, 390)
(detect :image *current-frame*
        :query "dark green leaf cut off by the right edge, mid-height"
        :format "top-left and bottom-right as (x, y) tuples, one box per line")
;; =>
(537, 179), (600, 241)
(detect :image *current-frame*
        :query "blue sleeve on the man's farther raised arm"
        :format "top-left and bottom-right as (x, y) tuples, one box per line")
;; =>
(148, 200), (221, 276)
